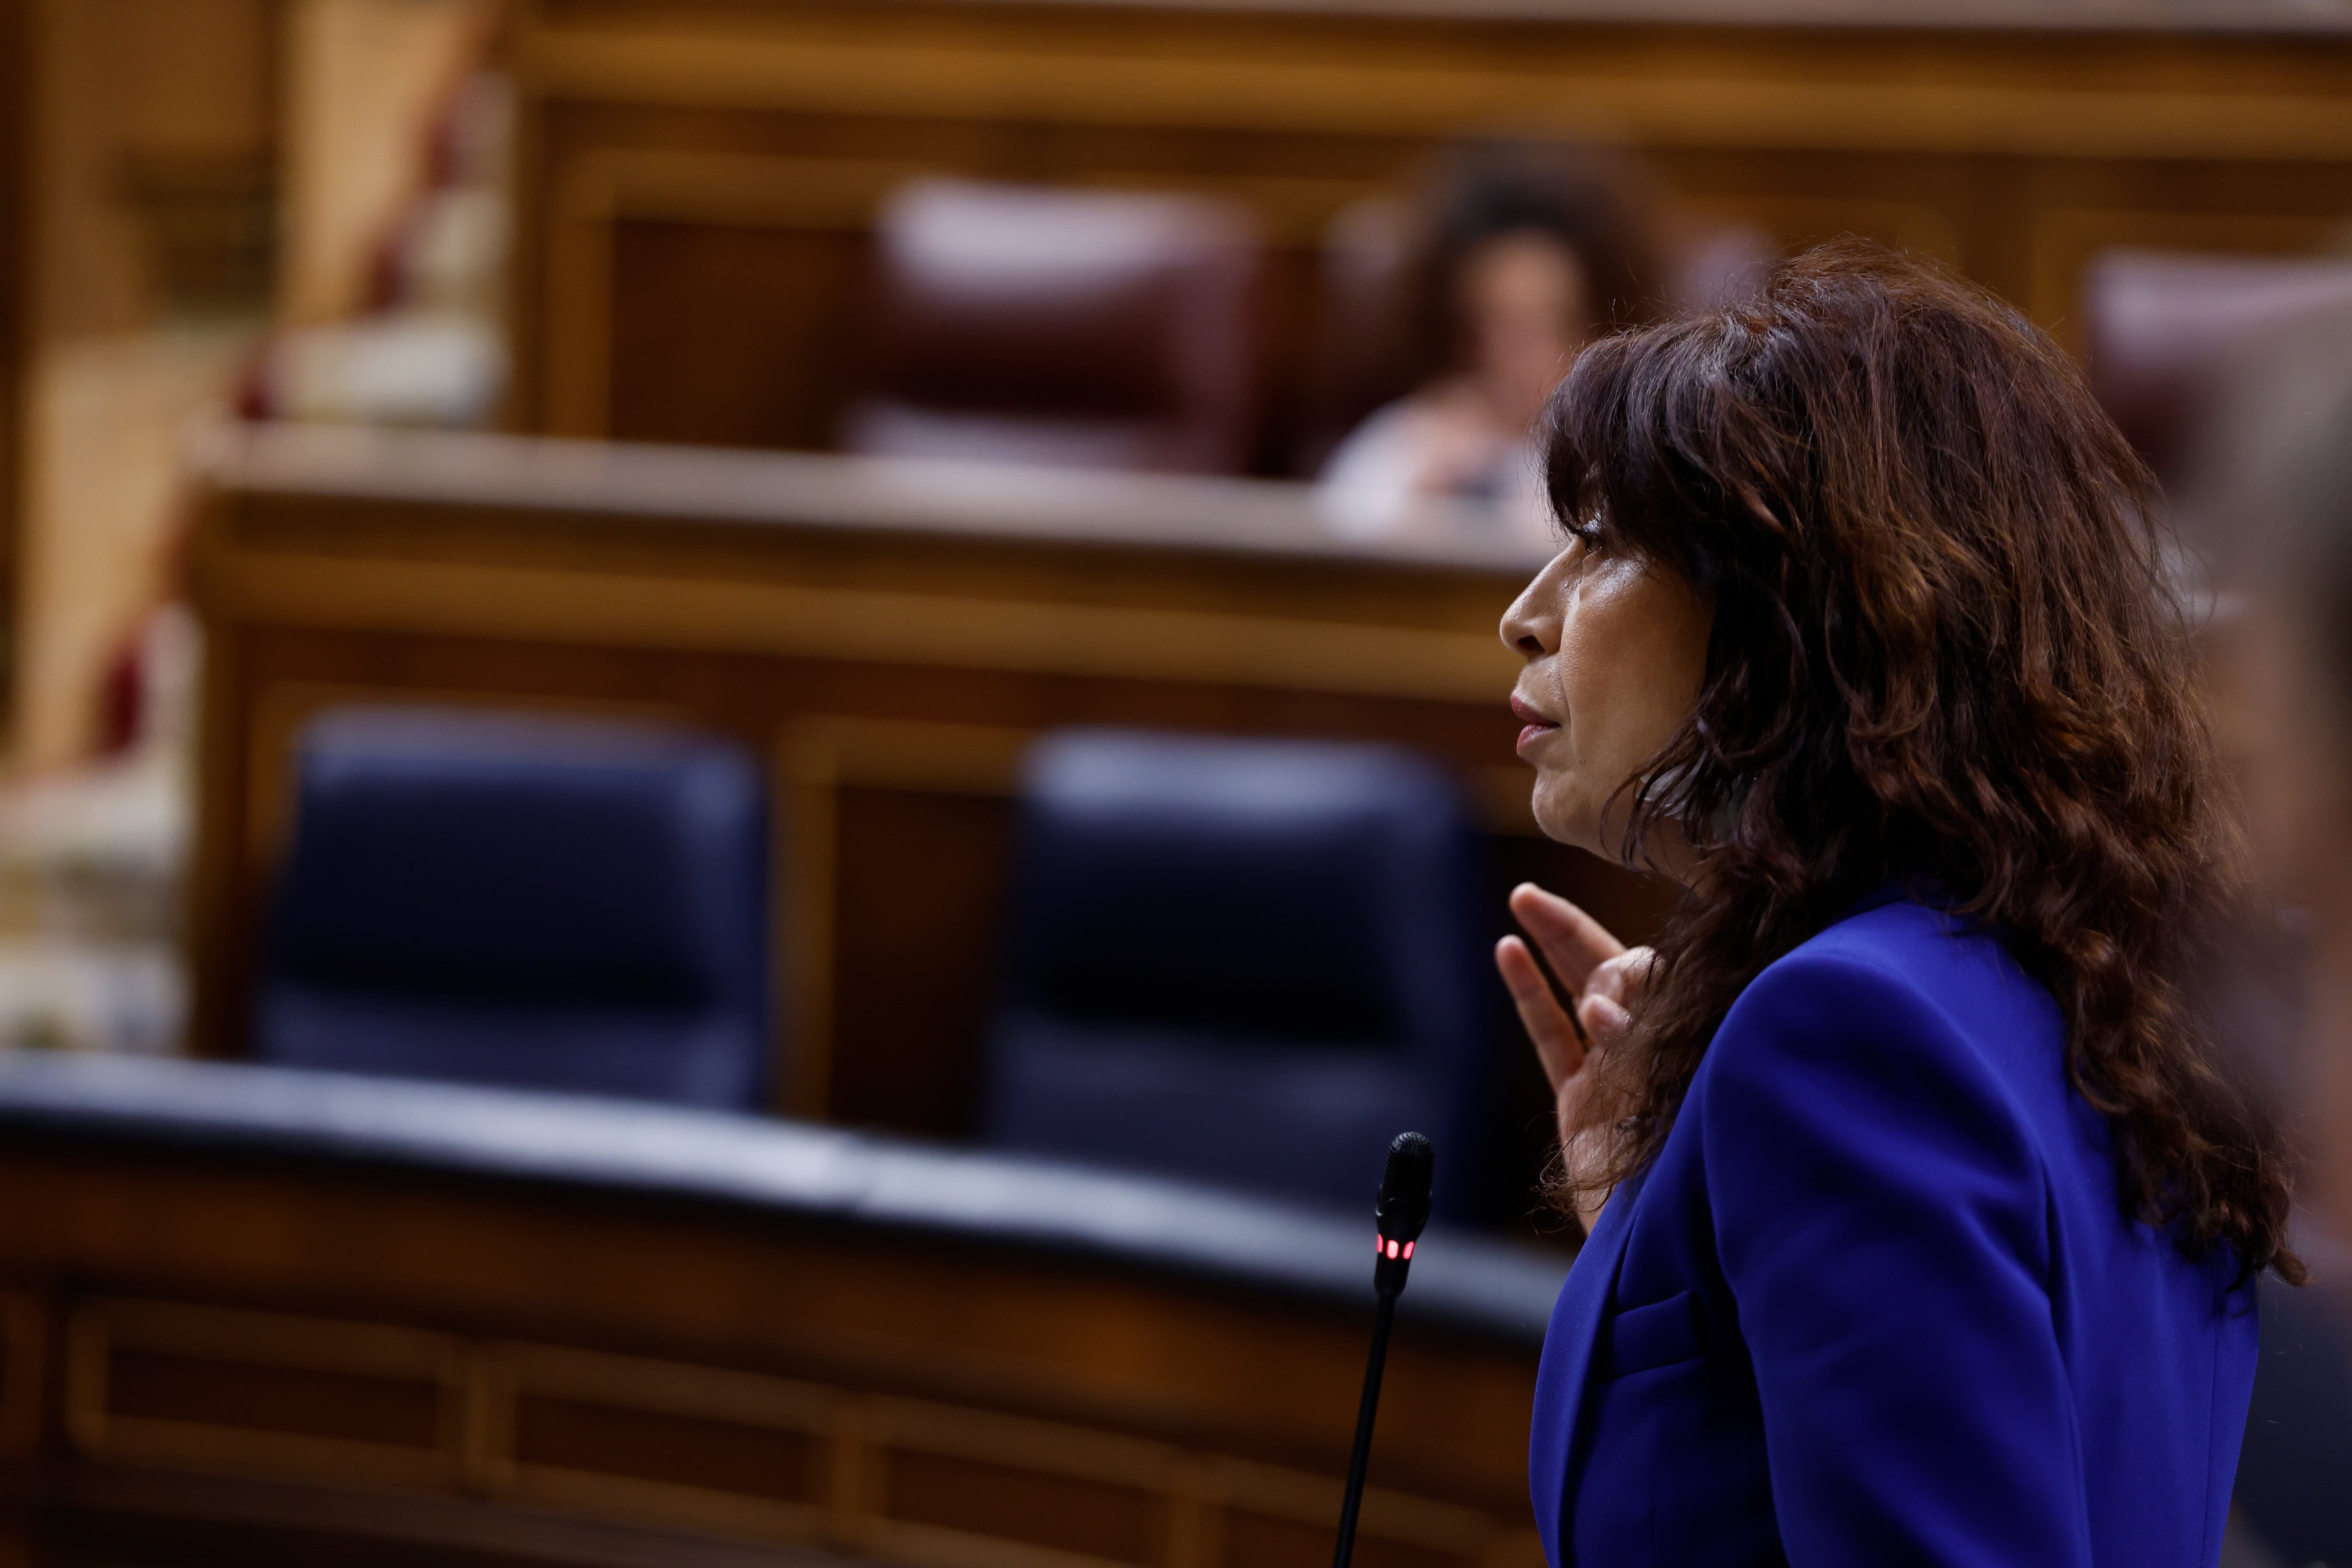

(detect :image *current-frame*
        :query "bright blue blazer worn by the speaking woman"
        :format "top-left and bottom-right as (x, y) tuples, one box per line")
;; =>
(1529, 893), (2256, 1568)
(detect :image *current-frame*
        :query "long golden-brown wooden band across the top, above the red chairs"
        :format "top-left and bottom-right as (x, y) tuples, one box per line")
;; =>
(517, 0), (2352, 158)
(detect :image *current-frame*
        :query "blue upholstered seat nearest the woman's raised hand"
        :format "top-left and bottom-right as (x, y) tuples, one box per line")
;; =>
(983, 731), (1489, 1213)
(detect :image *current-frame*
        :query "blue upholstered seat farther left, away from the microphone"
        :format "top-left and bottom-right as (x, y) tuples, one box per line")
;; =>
(254, 708), (769, 1110)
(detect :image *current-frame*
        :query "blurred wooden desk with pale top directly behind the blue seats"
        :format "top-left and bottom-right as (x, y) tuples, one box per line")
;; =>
(191, 428), (1661, 1162)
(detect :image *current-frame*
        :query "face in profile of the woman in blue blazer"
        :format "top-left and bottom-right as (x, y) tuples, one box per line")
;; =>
(1503, 524), (1715, 870)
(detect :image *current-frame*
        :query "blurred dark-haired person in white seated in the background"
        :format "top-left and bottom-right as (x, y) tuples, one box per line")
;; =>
(1322, 141), (1661, 552)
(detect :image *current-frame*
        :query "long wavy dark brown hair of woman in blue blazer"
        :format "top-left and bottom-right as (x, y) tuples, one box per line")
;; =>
(1545, 242), (2303, 1281)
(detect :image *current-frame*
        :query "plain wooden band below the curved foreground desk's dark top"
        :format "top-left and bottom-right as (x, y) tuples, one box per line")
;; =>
(9, 1157), (1529, 1507)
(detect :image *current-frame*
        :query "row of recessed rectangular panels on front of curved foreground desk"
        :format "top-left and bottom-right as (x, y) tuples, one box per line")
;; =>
(50, 1297), (1524, 1568)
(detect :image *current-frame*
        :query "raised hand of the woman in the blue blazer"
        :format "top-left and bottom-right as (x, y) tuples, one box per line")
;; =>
(1494, 882), (1656, 1225)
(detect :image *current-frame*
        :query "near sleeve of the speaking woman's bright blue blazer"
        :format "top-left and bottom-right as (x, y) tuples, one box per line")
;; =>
(1693, 955), (2091, 1568)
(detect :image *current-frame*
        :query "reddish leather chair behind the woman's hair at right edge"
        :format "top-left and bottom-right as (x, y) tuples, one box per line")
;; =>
(2084, 249), (2352, 484)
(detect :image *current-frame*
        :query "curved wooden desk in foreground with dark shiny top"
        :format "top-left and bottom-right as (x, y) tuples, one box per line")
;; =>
(0, 1053), (1564, 1568)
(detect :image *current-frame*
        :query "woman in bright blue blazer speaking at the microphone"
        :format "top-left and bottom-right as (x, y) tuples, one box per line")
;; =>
(1498, 249), (2300, 1568)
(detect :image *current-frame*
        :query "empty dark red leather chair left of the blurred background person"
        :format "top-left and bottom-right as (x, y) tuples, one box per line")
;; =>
(842, 179), (1261, 472)
